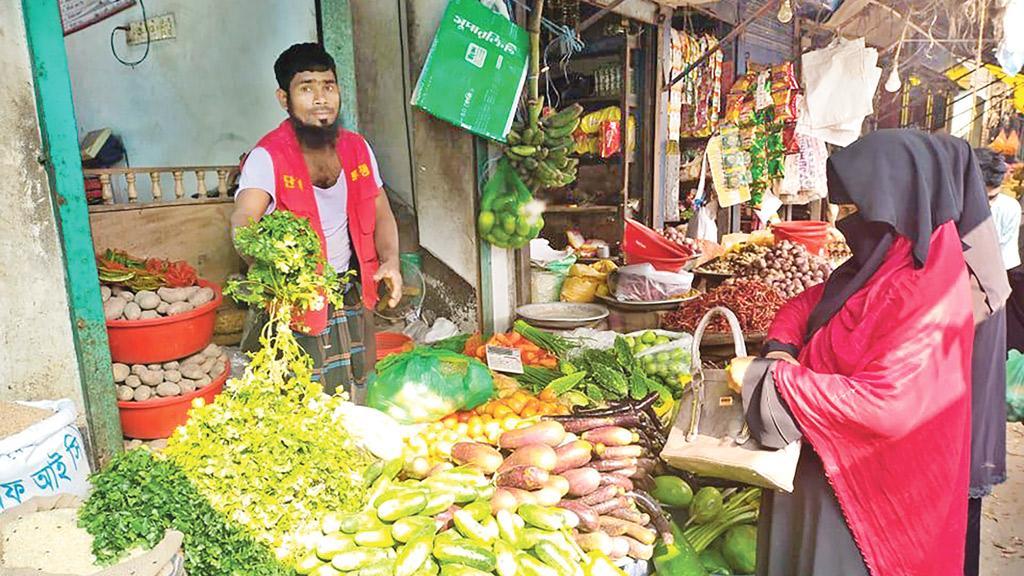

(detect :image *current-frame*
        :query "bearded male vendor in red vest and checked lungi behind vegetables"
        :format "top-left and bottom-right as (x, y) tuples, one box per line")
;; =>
(231, 43), (401, 402)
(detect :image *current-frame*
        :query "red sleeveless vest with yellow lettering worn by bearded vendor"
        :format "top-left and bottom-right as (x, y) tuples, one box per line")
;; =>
(249, 120), (380, 334)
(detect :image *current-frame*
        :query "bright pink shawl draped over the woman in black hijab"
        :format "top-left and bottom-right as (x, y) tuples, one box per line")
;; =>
(769, 222), (974, 576)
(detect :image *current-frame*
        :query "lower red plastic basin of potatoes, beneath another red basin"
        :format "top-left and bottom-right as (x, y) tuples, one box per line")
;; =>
(118, 361), (230, 440)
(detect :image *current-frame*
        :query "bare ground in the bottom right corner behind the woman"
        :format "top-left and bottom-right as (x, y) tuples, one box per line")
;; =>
(981, 422), (1024, 576)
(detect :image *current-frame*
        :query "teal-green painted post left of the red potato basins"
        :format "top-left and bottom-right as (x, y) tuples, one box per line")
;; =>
(22, 0), (123, 462)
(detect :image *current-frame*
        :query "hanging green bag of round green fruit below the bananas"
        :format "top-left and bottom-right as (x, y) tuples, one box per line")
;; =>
(476, 158), (544, 249)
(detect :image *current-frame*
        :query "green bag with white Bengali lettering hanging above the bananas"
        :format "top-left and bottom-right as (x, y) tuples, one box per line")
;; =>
(412, 0), (529, 142)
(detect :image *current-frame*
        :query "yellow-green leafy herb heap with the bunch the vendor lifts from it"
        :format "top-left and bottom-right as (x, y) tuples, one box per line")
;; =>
(166, 212), (374, 560)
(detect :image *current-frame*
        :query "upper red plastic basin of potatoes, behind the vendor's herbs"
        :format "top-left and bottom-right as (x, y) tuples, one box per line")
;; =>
(106, 280), (224, 364)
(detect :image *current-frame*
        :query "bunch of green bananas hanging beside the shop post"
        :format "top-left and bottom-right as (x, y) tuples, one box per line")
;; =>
(505, 99), (583, 192)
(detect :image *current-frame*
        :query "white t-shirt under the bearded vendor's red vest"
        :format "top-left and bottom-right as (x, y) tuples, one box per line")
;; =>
(239, 145), (384, 272)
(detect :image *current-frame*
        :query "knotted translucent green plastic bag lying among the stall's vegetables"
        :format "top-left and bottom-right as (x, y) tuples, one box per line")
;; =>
(367, 347), (495, 424)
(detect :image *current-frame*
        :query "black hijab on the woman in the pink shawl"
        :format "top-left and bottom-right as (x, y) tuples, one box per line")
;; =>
(806, 130), (1009, 339)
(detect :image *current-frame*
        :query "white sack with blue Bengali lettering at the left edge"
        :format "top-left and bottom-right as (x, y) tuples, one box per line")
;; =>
(0, 399), (91, 509)
